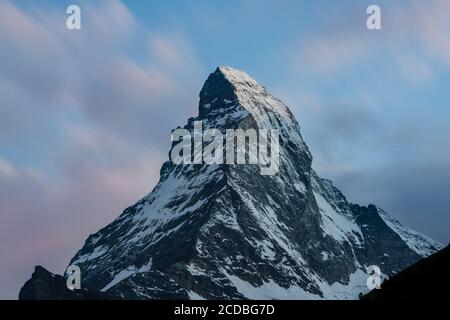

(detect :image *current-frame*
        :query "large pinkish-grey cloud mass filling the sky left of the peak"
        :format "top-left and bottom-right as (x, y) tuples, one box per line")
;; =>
(0, 1), (203, 298)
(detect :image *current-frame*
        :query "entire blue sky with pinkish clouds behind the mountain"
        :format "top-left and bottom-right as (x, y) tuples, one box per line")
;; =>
(0, 0), (450, 299)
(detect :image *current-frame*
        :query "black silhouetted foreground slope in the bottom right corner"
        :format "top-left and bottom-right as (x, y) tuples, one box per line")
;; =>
(362, 245), (450, 301)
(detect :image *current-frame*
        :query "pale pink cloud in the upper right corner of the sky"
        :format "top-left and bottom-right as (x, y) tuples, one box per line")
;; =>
(289, 0), (450, 84)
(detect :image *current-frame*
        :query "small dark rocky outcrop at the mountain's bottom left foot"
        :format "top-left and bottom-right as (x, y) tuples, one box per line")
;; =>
(19, 266), (111, 300)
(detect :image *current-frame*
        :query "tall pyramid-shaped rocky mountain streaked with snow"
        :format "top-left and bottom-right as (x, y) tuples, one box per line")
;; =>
(70, 67), (441, 299)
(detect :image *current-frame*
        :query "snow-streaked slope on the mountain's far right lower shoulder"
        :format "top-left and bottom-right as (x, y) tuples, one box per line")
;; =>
(377, 207), (443, 257)
